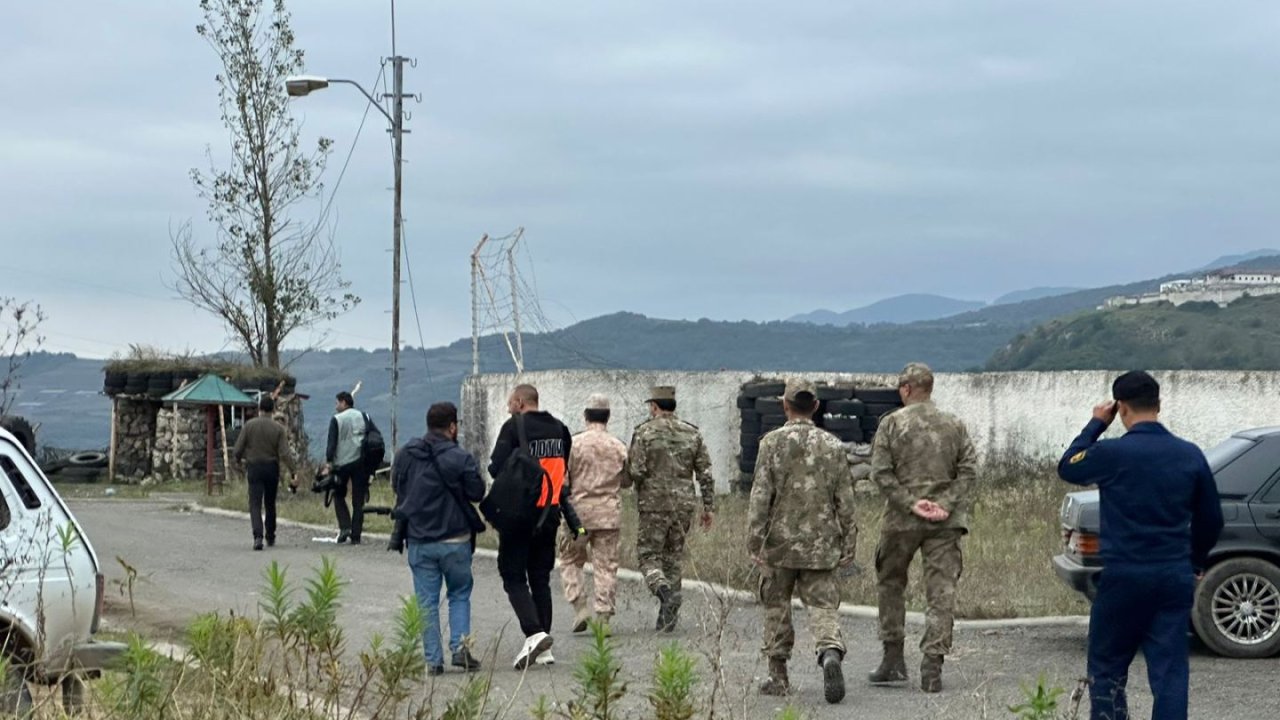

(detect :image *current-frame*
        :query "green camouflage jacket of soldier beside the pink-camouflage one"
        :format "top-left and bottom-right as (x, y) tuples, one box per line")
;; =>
(627, 413), (716, 512)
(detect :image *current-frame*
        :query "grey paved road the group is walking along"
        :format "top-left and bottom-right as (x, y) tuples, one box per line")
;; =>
(70, 498), (1280, 720)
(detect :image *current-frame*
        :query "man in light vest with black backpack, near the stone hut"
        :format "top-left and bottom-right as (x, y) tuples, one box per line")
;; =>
(321, 391), (384, 544)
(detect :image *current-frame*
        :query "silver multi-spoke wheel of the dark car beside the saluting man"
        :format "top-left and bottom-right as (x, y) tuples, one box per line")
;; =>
(1192, 557), (1280, 657)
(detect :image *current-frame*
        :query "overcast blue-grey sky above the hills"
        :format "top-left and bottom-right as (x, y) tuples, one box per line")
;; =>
(0, 0), (1280, 356)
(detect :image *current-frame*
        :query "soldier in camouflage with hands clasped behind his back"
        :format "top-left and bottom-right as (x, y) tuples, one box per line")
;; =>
(869, 363), (978, 693)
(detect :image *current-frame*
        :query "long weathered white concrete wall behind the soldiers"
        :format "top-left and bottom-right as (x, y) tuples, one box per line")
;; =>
(462, 370), (1280, 489)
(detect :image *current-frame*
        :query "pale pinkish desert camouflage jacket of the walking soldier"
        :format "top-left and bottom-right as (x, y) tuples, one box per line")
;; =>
(568, 423), (631, 530)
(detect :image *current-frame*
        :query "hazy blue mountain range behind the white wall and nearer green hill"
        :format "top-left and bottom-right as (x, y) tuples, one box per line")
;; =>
(14, 245), (1280, 448)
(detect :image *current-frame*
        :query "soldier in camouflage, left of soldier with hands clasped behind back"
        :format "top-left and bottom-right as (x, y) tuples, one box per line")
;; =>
(748, 379), (858, 702)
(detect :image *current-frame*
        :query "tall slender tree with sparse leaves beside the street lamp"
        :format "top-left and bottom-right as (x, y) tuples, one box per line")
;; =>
(170, 0), (360, 368)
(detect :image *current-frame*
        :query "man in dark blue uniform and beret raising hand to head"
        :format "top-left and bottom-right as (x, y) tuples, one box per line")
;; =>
(1057, 370), (1222, 720)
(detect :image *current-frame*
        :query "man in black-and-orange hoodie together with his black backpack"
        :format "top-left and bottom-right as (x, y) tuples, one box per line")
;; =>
(480, 384), (586, 670)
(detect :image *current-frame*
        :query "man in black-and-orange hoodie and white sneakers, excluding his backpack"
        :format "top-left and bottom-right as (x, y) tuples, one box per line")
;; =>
(489, 384), (586, 670)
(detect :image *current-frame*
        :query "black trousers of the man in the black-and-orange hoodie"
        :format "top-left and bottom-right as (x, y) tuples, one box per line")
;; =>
(498, 523), (557, 638)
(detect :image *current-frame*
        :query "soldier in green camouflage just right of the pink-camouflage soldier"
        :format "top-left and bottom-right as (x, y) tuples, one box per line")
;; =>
(627, 386), (716, 633)
